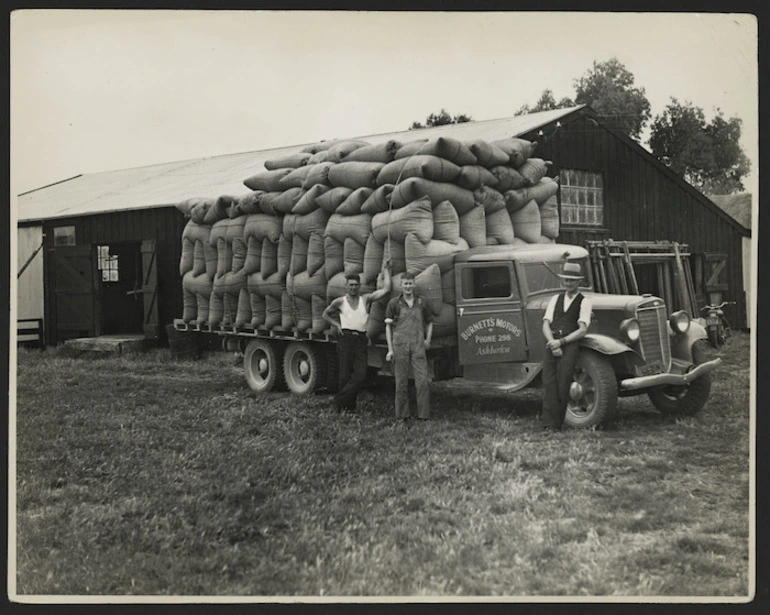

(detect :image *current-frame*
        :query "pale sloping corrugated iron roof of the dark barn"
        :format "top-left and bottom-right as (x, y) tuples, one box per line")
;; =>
(17, 105), (585, 222)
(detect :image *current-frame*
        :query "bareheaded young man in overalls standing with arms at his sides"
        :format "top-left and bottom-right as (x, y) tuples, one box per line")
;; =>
(385, 271), (433, 420)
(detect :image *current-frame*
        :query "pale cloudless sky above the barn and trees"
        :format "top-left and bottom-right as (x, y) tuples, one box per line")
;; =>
(11, 9), (758, 194)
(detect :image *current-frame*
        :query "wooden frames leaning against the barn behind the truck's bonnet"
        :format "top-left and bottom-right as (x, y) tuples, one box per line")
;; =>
(586, 239), (698, 318)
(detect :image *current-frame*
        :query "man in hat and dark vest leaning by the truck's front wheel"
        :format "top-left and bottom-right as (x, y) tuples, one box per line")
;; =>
(540, 262), (591, 430)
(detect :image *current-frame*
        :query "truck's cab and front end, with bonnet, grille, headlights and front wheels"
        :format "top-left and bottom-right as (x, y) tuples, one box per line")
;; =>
(455, 244), (720, 427)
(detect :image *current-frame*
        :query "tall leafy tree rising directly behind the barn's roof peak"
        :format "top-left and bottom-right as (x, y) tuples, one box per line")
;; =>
(574, 58), (650, 141)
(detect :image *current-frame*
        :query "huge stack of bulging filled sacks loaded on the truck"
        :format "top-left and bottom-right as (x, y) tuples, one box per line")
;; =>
(179, 132), (558, 337)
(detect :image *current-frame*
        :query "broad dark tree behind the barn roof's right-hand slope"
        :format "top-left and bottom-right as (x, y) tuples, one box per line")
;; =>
(650, 97), (751, 194)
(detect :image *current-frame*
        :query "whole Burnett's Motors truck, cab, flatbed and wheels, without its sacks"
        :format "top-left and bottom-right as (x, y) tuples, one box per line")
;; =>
(174, 244), (720, 427)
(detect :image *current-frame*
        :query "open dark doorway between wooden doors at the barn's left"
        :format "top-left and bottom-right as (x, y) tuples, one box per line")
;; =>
(97, 242), (144, 335)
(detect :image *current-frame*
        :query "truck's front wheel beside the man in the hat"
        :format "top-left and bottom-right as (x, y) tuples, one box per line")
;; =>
(564, 349), (618, 428)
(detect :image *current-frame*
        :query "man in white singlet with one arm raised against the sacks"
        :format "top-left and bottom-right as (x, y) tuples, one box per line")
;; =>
(322, 260), (390, 412)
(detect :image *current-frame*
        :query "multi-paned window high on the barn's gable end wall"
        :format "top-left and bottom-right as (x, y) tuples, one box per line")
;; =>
(559, 169), (604, 226)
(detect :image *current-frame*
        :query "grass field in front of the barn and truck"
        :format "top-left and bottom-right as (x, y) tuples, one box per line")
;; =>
(16, 334), (750, 597)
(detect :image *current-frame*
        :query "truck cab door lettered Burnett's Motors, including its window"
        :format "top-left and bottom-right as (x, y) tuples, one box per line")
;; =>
(455, 263), (528, 365)
